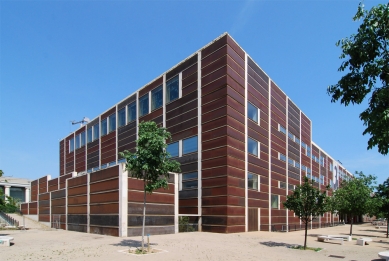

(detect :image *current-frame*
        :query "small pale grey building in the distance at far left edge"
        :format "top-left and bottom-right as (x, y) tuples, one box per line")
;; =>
(0, 177), (31, 202)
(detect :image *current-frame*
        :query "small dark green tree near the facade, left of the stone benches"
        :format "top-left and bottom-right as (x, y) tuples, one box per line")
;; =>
(283, 177), (328, 250)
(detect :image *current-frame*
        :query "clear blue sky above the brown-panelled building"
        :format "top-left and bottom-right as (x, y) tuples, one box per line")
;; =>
(0, 0), (389, 183)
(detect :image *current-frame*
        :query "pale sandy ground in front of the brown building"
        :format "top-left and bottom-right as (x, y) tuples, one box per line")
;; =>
(0, 214), (389, 261)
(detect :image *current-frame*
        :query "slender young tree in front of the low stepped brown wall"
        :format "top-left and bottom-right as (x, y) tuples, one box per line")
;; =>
(119, 121), (180, 252)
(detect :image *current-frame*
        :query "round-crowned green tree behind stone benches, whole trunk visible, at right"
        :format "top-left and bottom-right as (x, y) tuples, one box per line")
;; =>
(333, 171), (377, 236)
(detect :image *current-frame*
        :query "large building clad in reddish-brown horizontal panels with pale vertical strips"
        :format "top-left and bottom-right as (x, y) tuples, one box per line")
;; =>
(20, 33), (351, 236)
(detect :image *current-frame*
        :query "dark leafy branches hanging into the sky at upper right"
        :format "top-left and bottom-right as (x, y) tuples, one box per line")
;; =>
(327, 3), (389, 155)
